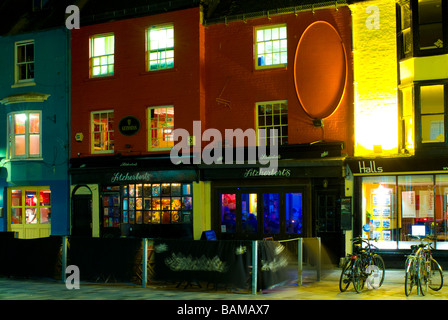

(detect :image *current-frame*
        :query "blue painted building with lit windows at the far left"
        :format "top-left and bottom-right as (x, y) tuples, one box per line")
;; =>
(0, 0), (70, 238)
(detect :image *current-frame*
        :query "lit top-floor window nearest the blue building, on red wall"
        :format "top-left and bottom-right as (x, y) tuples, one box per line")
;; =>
(89, 33), (115, 78)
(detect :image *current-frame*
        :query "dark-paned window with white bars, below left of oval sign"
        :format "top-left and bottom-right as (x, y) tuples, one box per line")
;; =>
(257, 101), (288, 145)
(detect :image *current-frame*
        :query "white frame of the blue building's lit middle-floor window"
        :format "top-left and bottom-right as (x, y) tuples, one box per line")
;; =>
(7, 110), (42, 160)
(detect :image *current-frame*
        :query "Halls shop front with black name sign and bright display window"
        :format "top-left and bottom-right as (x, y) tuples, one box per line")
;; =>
(348, 157), (448, 268)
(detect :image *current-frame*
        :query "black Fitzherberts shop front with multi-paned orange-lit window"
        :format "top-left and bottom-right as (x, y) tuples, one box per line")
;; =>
(71, 158), (197, 239)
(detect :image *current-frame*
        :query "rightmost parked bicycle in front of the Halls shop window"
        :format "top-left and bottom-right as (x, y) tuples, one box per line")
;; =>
(404, 235), (443, 296)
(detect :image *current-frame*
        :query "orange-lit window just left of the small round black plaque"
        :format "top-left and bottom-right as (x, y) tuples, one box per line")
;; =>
(90, 110), (114, 153)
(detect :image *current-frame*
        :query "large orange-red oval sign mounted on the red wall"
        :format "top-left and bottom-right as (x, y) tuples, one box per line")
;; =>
(294, 21), (347, 119)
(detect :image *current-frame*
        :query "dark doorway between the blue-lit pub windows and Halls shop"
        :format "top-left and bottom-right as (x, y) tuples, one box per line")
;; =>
(315, 190), (342, 264)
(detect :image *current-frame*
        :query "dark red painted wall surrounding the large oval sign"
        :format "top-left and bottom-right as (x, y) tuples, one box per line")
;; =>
(205, 8), (354, 155)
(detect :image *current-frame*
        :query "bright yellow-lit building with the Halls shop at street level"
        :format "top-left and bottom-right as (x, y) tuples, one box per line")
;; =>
(348, 0), (448, 264)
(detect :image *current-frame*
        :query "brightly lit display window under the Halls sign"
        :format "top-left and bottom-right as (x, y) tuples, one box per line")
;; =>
(362, 175), (448, 249)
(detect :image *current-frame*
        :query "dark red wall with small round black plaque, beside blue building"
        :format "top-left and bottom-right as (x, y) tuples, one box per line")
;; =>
(71, 8), (204, 157)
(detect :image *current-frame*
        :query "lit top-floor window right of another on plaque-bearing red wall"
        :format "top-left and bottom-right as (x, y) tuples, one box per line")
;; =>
(146, 24), (175, 71)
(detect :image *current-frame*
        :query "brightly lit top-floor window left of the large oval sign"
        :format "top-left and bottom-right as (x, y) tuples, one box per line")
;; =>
(255, 25), (288, 69)
